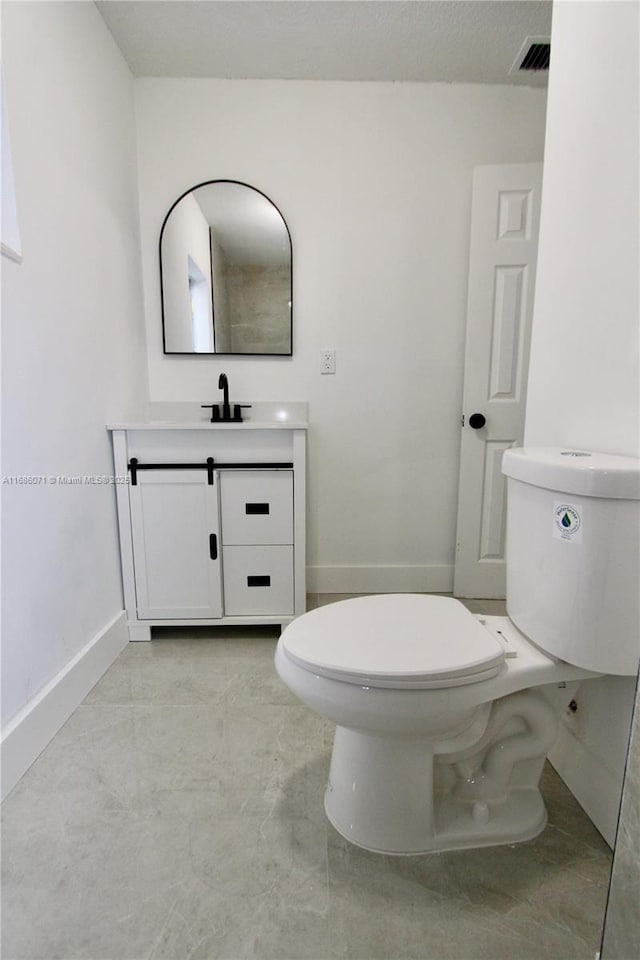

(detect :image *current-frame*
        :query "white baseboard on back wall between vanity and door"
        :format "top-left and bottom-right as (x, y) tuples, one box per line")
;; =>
(307, 564), (453, 593)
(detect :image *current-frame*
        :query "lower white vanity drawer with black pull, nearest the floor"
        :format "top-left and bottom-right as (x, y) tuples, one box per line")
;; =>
(223, 546), (293, 617)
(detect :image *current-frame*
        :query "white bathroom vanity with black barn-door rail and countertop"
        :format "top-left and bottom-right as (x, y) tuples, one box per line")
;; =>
(108, 403), (308, 640)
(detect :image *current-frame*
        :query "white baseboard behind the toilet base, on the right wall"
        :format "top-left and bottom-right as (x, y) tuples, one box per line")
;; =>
(548, 723), (622, 849)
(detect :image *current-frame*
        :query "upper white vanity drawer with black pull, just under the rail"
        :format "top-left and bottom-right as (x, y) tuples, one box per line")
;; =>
(220, 470), (293, 546)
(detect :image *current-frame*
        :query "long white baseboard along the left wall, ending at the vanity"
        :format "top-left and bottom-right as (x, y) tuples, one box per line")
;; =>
(1, 610), (129, 800)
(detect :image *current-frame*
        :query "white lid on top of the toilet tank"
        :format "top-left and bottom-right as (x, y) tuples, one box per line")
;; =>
(502, 447), (640, 500)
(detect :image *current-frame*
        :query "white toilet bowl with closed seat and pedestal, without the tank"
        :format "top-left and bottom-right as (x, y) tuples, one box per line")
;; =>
(276, 594), (595, 854)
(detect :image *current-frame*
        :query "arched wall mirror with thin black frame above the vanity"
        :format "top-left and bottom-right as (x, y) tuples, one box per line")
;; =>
(160, 180), (292, 356)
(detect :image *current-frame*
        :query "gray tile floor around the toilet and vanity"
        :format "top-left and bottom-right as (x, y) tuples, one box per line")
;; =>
(2, 596), (611, 960)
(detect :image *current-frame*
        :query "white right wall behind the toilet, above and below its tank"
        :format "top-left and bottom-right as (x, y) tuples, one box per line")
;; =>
(524, 2), (640, 842)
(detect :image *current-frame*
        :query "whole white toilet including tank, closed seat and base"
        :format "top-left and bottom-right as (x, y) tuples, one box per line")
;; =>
(276, 448), (640, 854)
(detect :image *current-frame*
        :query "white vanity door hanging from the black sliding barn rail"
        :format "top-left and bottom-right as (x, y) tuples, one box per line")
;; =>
(129, 470), (222, 620)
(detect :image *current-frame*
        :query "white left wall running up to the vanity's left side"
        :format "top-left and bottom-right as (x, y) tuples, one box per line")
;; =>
(2, 3), (147, 759)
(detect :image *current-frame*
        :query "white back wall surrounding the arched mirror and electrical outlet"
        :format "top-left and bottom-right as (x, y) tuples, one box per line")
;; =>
(136, 79), (546, 592)
